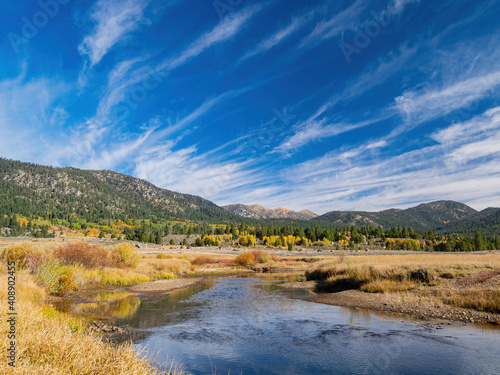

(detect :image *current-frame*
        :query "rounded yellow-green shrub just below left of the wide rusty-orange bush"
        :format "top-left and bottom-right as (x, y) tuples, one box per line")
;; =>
(35, 258), (75, 295)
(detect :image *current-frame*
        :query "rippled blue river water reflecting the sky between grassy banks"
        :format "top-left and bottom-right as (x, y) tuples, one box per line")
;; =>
(114, 278), (500, 375)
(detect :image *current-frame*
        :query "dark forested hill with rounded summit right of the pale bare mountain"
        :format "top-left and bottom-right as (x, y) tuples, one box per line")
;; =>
(313, 201), (477, 231)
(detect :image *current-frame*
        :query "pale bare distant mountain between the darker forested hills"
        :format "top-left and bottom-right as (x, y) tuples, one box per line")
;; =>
(223, 204), (318, 220)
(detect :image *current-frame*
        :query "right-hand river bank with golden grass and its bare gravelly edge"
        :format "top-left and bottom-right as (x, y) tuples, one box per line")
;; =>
(281, 253), (500, 325)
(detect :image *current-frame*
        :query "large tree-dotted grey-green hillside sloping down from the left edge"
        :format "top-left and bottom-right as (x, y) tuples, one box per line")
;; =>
(0, 159), (235, 222)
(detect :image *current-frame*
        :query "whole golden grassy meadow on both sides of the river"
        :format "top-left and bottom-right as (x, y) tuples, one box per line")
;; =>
(0, 241), (500, 375)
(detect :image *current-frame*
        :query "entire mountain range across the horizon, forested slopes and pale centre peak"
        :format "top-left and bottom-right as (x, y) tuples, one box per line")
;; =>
(0, 159), (500, 233)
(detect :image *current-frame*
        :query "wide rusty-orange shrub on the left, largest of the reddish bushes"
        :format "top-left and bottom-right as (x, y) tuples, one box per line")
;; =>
(54, 242), (117, 268)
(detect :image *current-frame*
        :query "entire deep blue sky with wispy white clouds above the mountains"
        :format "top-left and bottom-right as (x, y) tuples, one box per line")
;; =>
(0, 0), (500, 214)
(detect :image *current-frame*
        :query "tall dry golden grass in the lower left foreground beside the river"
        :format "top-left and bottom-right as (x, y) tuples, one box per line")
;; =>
(0, 273), (188, 375)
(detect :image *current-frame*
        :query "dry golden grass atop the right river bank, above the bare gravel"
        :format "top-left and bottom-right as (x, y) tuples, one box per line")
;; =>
(306, 253), (500, 313)
